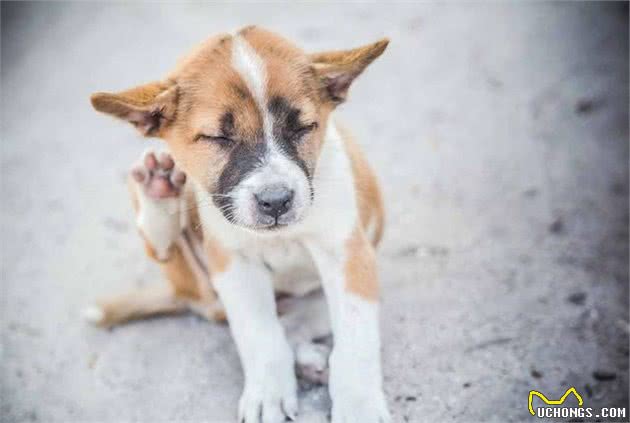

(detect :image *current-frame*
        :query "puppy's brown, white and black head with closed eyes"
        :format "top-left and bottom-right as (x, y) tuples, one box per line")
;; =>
(92, 27), (388, 231)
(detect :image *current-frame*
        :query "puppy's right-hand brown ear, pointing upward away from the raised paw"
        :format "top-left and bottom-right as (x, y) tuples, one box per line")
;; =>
(310, 38), (389, 104)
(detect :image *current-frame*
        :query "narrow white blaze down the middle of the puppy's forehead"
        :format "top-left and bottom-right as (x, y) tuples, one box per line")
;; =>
(232, 35), (272, 138)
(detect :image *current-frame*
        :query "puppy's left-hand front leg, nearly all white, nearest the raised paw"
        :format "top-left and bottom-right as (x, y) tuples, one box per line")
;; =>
(213, 255), (297, 423)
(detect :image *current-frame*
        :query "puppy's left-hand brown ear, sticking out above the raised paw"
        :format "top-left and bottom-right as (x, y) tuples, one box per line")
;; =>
(90, 81), (177, 137)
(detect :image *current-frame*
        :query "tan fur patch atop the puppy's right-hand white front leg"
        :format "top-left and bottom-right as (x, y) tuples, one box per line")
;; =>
(344, 227), (379, 301)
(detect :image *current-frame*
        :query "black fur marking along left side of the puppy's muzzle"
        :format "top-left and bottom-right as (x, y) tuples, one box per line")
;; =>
(213, 131), (267, 222)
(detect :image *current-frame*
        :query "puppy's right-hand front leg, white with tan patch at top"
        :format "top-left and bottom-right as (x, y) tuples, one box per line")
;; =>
(308, 228), (390, 423)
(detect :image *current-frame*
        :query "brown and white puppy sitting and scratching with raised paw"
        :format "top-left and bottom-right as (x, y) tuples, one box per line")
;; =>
(86, 26), (390, 423)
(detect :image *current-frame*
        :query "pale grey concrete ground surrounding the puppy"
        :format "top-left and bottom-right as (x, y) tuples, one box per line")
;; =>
(0, 2), (630, 423)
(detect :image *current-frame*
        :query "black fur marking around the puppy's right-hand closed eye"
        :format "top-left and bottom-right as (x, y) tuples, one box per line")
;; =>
(268, 96), (311, 182)
